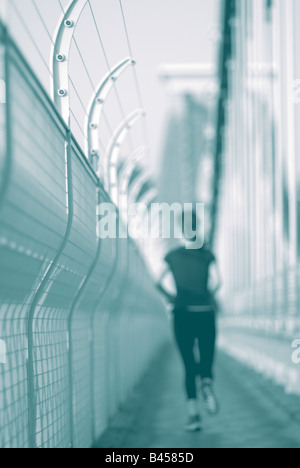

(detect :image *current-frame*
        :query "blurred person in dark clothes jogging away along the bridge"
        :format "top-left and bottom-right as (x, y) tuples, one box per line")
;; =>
(158, 213), (221, 432)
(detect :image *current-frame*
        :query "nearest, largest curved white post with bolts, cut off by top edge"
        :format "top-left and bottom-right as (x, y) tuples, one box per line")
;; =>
(50, 0), (88, 126)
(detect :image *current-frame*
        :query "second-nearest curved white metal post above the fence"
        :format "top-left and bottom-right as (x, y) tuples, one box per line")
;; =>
(85, 57), (135, 169)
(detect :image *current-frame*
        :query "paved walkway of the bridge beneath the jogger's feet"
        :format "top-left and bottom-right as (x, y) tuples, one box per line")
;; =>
(98, 347), (300, 448)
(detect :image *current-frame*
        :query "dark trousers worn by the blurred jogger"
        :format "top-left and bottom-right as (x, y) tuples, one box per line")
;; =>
(174, 311), (216, 399)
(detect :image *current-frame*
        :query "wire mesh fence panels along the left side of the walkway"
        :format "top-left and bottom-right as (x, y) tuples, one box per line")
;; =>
(0, 22), (166, 448)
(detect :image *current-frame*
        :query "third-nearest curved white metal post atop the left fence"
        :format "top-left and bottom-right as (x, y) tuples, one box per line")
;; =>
(103, 109), (146, 204)
